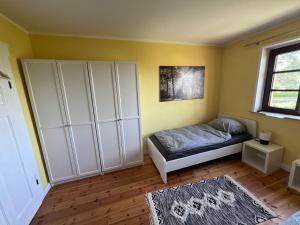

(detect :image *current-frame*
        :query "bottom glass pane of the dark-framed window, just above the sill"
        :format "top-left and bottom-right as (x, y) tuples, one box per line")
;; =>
(269, 91), (298, 110)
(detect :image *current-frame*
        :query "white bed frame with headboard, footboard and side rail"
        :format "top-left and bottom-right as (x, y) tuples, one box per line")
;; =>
(147, 114), (256, 183)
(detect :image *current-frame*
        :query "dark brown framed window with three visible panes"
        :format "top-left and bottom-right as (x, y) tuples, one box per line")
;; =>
(262, 44), (300, 116)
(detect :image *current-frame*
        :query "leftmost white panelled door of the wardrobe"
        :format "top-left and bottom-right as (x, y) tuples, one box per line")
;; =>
(22, 60), (76, 183)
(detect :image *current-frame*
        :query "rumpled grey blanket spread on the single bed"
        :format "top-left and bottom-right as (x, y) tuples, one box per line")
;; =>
(155, 124), (231, 152)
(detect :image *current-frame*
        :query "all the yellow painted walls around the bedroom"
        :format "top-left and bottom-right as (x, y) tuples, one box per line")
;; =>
(4, 10), (300, 186)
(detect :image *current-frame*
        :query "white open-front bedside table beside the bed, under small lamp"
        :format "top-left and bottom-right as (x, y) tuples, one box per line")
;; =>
(242, 140), (283, 174)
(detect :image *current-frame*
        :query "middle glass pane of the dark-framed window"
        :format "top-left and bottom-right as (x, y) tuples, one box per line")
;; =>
(272, 72), (300, 90)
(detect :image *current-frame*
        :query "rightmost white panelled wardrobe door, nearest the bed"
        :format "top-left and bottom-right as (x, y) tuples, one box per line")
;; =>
(115, 62), (143, 166)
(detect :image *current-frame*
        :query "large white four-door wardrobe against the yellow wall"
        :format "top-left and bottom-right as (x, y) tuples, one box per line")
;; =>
(22, 59), (143, 184)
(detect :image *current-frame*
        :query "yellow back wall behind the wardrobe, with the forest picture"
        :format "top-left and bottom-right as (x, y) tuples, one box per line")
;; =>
(30, 35), (221, 147)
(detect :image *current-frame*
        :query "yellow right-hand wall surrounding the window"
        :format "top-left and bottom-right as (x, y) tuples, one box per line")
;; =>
(219, 21), (300, 164)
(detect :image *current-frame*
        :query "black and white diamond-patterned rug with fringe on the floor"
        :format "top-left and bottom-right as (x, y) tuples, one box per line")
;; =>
(147, 175), (277, 225)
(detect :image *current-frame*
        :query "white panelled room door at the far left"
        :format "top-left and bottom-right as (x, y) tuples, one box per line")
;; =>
(0, 45), (43, 225)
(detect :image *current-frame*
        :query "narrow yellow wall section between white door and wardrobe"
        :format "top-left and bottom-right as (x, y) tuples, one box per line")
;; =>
(0, 16), (47, 187)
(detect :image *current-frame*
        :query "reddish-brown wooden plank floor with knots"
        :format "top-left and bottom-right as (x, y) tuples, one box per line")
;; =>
(32, 156), (300, 225)
